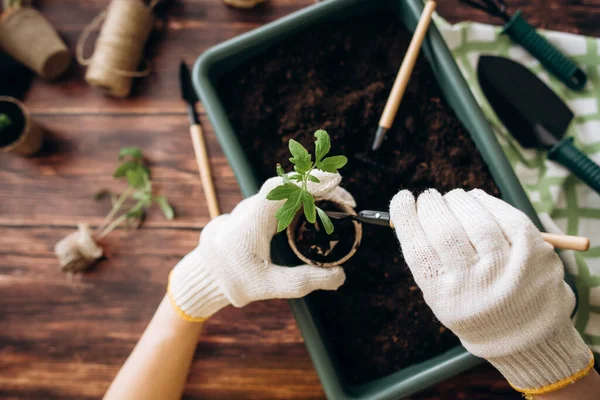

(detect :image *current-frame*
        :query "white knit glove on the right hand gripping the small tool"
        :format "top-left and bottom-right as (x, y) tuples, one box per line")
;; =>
(390, 189), (594, 395)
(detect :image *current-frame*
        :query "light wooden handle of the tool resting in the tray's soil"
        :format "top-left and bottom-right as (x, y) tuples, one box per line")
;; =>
(379, 0), (436, 129)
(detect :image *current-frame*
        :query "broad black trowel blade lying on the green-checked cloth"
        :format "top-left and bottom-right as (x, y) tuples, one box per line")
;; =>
(477, 56), (573, 148)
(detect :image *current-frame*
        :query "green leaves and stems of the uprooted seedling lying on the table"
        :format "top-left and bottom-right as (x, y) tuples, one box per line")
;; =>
(94, 147), (175, 239)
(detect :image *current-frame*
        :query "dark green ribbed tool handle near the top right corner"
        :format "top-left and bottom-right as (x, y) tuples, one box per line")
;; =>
(502, 10), (587, 90)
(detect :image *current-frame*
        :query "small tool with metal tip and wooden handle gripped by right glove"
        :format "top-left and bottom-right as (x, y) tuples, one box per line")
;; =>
(325, 210), (590, 251)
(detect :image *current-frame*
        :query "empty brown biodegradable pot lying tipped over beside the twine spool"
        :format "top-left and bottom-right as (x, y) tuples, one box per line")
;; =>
(0, 7), (71, 79)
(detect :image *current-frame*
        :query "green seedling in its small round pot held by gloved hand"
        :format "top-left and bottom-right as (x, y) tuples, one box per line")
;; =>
(267, 130), (362, 267)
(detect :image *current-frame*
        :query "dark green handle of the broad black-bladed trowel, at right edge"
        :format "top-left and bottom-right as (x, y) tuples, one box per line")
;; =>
(548, 137), (600, 194)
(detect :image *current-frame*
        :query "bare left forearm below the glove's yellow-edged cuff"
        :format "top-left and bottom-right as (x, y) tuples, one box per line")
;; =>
(104, 296), (202, 400)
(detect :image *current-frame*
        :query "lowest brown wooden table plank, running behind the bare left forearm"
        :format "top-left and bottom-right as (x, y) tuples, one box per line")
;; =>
(0, 227), (322, 399)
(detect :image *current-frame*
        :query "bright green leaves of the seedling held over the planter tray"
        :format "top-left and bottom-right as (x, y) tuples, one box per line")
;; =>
(267, 130), (348, 235)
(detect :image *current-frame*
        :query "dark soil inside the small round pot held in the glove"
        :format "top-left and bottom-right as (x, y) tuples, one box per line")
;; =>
(296, 201), (356, 263)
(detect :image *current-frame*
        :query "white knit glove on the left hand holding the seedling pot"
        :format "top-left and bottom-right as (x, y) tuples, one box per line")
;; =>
(168, 171), (356, 321)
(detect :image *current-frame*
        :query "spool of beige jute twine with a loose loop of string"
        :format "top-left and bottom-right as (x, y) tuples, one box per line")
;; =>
(77, 0), (158, 97)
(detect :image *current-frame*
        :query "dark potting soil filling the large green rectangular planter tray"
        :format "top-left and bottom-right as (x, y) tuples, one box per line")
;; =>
(219, 10), (499, 384)
